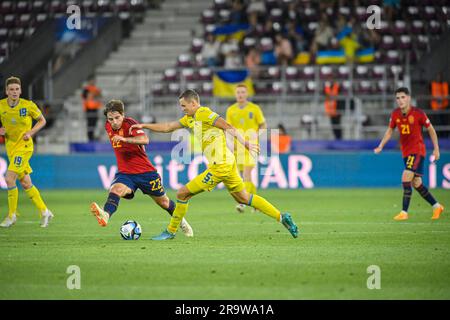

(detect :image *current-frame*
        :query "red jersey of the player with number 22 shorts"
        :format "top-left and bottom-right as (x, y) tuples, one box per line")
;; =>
(105, 118), (156, 174)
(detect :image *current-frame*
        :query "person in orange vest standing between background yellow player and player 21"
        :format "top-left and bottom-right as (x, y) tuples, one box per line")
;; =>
(324, 76), (345, 140)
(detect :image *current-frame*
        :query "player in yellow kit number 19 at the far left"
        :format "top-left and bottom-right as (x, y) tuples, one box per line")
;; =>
(0, 77), (53, 228)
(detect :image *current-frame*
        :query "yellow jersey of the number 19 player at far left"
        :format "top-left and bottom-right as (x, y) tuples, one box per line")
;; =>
(0, 98), (42, 156)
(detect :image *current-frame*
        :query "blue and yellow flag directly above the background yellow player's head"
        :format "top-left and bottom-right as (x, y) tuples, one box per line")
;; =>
(213, 69), (255, 98)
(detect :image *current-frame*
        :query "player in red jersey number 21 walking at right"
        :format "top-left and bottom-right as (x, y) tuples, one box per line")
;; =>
(374, 88), (444, 221)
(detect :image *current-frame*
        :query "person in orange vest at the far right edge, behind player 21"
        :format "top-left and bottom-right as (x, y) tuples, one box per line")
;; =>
(430, 72), (450, 138)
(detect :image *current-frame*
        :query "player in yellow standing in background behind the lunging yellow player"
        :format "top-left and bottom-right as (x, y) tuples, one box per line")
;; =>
(226, 84), (267, 213)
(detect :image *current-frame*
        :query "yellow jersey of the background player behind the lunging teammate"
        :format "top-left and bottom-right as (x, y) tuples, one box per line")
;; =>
(226, 102), (266, 138)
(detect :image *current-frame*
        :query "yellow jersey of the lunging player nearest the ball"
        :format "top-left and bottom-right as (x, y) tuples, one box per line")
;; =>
(179, 107), (235, 166)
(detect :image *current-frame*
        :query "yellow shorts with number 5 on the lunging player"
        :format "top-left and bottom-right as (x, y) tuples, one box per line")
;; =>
(186, 163), (245, 194)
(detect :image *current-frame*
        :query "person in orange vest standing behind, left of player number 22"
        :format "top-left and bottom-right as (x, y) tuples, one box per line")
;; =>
(81, 76), (102, 141)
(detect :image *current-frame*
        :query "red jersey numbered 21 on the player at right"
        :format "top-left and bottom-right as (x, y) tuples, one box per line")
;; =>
(389, 107), (431, 157)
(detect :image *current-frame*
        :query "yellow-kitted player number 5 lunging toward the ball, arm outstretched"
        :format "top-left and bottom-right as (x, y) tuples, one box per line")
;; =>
(130, 90), (298, 240)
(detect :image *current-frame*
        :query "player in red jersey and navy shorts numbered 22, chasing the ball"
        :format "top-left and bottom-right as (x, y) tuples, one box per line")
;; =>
(91, 100), (194, 237)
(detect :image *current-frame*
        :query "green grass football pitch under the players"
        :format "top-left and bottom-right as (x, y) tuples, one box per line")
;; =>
(0, 189), (450, 299)
